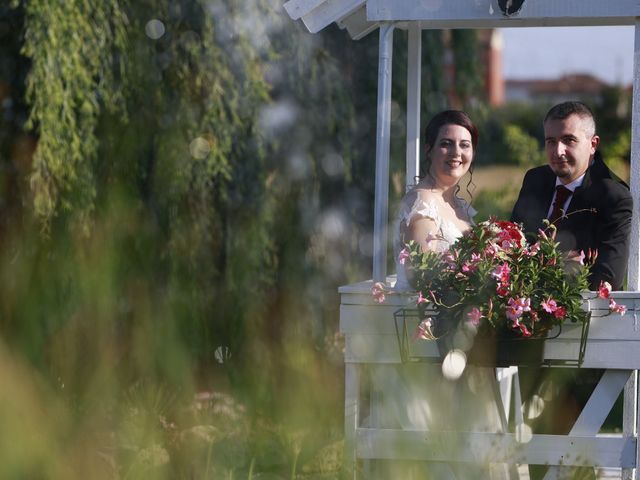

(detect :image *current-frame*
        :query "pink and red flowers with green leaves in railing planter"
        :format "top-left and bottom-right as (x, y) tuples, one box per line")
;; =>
(398, 218), (596, 339)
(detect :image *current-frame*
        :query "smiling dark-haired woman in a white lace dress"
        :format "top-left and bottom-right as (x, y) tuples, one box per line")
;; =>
(372, 110), (515, 480)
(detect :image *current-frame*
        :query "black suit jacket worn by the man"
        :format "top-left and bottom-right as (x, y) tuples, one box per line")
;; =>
(511, 152), (633, 290)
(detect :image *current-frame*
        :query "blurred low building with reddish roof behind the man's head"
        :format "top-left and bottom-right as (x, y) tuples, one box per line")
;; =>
(505, 73), (608, 103)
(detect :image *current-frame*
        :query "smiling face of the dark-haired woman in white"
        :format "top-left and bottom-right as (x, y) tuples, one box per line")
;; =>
(427, 124), (473, 185)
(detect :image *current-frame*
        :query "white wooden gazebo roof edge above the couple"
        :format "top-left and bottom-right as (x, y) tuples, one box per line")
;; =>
(284, 0), (640, 39)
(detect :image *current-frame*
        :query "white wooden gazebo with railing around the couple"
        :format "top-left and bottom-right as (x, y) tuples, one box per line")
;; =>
(284, 0), (640, 479)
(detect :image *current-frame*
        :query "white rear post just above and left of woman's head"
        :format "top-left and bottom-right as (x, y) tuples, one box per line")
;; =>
(405, 23), (422, 190)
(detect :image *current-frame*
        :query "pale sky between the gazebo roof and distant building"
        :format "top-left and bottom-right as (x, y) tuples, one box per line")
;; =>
(502, 26), (634, 85)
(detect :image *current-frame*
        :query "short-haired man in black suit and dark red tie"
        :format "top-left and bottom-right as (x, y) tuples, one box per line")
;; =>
(511, 102), (632, 290)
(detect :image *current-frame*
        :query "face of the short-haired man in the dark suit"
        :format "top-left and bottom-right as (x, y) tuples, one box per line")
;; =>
(544, 114), (600, 185)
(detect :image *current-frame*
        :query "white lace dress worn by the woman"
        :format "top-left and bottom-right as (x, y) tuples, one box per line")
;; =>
(364, 195), (517, 480)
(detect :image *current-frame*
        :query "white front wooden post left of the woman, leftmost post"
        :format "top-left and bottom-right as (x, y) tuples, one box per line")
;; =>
(373, 23), (394, 282)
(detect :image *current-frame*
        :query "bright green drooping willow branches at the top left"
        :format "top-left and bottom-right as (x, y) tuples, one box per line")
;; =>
(23, 0), (127, 227)
